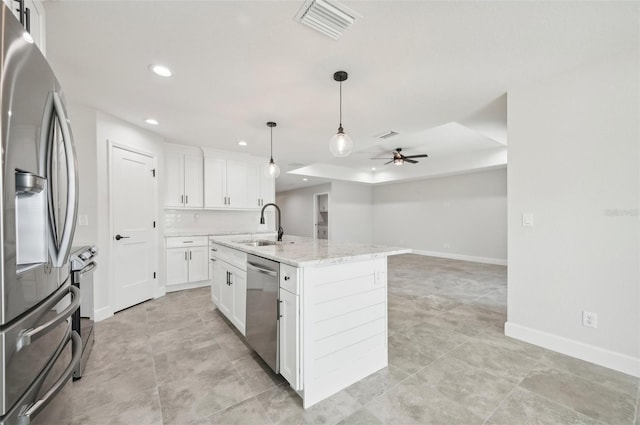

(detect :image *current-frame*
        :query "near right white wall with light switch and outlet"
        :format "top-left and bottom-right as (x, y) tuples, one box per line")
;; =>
(505, 49), (640, 376)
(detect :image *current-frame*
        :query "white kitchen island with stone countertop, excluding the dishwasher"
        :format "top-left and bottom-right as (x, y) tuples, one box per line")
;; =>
(210, 236), (410, 408)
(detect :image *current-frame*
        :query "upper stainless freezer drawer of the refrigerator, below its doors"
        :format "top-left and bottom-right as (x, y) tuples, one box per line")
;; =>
(0, 283), (80, 416)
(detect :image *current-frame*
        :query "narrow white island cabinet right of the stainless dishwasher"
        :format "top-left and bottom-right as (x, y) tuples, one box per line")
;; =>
(279, 263), (302, 391)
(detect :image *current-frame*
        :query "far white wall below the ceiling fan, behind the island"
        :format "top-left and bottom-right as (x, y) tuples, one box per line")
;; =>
(373, 168), (507, 264)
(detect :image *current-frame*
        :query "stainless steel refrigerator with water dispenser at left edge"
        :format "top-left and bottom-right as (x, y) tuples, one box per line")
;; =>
(0, 3), (82, 425)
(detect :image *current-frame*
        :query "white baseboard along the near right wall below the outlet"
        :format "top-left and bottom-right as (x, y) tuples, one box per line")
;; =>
(504, 322), (640, 377)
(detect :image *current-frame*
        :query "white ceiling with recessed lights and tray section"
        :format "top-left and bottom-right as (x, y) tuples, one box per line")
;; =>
(44, 0), (640, 190)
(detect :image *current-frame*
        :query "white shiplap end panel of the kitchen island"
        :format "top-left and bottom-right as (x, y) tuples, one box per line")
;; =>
(301, 257), (388, 408)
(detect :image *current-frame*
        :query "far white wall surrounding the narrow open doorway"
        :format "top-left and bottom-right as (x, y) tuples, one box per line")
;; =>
(276, 183), (334, 238)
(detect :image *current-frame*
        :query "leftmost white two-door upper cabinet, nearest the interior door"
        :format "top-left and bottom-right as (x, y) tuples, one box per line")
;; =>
(164, 152), (203, 208)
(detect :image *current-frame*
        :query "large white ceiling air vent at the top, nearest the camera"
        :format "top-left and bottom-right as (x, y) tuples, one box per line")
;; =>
(296, 0), (360, 40)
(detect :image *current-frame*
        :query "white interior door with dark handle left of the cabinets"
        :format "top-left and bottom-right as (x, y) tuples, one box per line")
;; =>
(111, 146), (157, 312)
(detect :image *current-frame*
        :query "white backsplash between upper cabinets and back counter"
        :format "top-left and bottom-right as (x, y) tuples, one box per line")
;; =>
(164, 209), (275, 234)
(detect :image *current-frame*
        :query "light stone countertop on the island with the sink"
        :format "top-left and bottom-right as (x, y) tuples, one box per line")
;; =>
(213, 235), (411, 267)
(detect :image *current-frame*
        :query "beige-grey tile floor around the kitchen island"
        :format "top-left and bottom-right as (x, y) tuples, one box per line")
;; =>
(70, 255), (640, 425)
